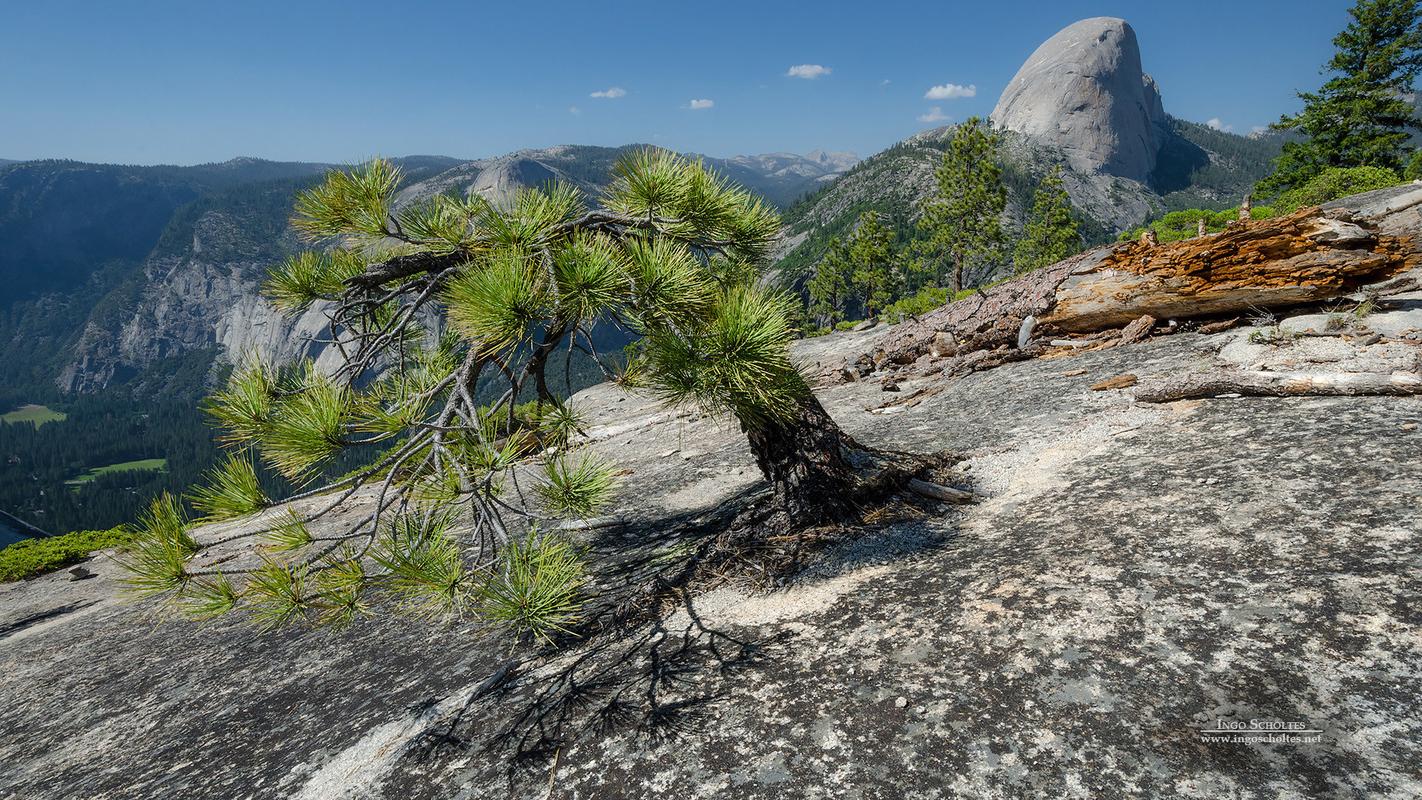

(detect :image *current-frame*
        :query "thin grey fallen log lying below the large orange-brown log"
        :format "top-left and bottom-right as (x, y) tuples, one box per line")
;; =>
(1135, 371), (1422, 402)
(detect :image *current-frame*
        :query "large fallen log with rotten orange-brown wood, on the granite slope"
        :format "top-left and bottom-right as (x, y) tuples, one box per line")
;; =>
(828, 185), (1422, 375)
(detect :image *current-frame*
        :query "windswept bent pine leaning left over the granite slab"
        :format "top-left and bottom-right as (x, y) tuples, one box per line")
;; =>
(119, 151), (916, 635)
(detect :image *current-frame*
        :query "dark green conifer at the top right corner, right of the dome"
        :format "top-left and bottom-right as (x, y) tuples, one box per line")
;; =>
(1258, 0), (1422, 195)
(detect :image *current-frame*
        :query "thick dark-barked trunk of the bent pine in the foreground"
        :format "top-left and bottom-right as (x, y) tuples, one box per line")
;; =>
(742, 391), (859, 527)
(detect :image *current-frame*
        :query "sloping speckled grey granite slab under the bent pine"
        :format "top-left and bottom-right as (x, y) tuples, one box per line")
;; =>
(0, 289), (1422, 800)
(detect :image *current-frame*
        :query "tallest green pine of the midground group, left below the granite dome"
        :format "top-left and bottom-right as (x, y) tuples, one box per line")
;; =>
(919, 117), (1007, 291)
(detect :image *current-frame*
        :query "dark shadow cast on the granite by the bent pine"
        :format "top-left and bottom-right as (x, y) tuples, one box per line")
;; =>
(404, 480), (961, 790)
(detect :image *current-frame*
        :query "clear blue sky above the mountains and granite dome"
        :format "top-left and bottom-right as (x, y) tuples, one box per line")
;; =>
(0, 0), (1351, 163)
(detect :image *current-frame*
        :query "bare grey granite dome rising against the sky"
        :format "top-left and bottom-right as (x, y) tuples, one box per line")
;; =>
(993, 17), (1169, 183)
